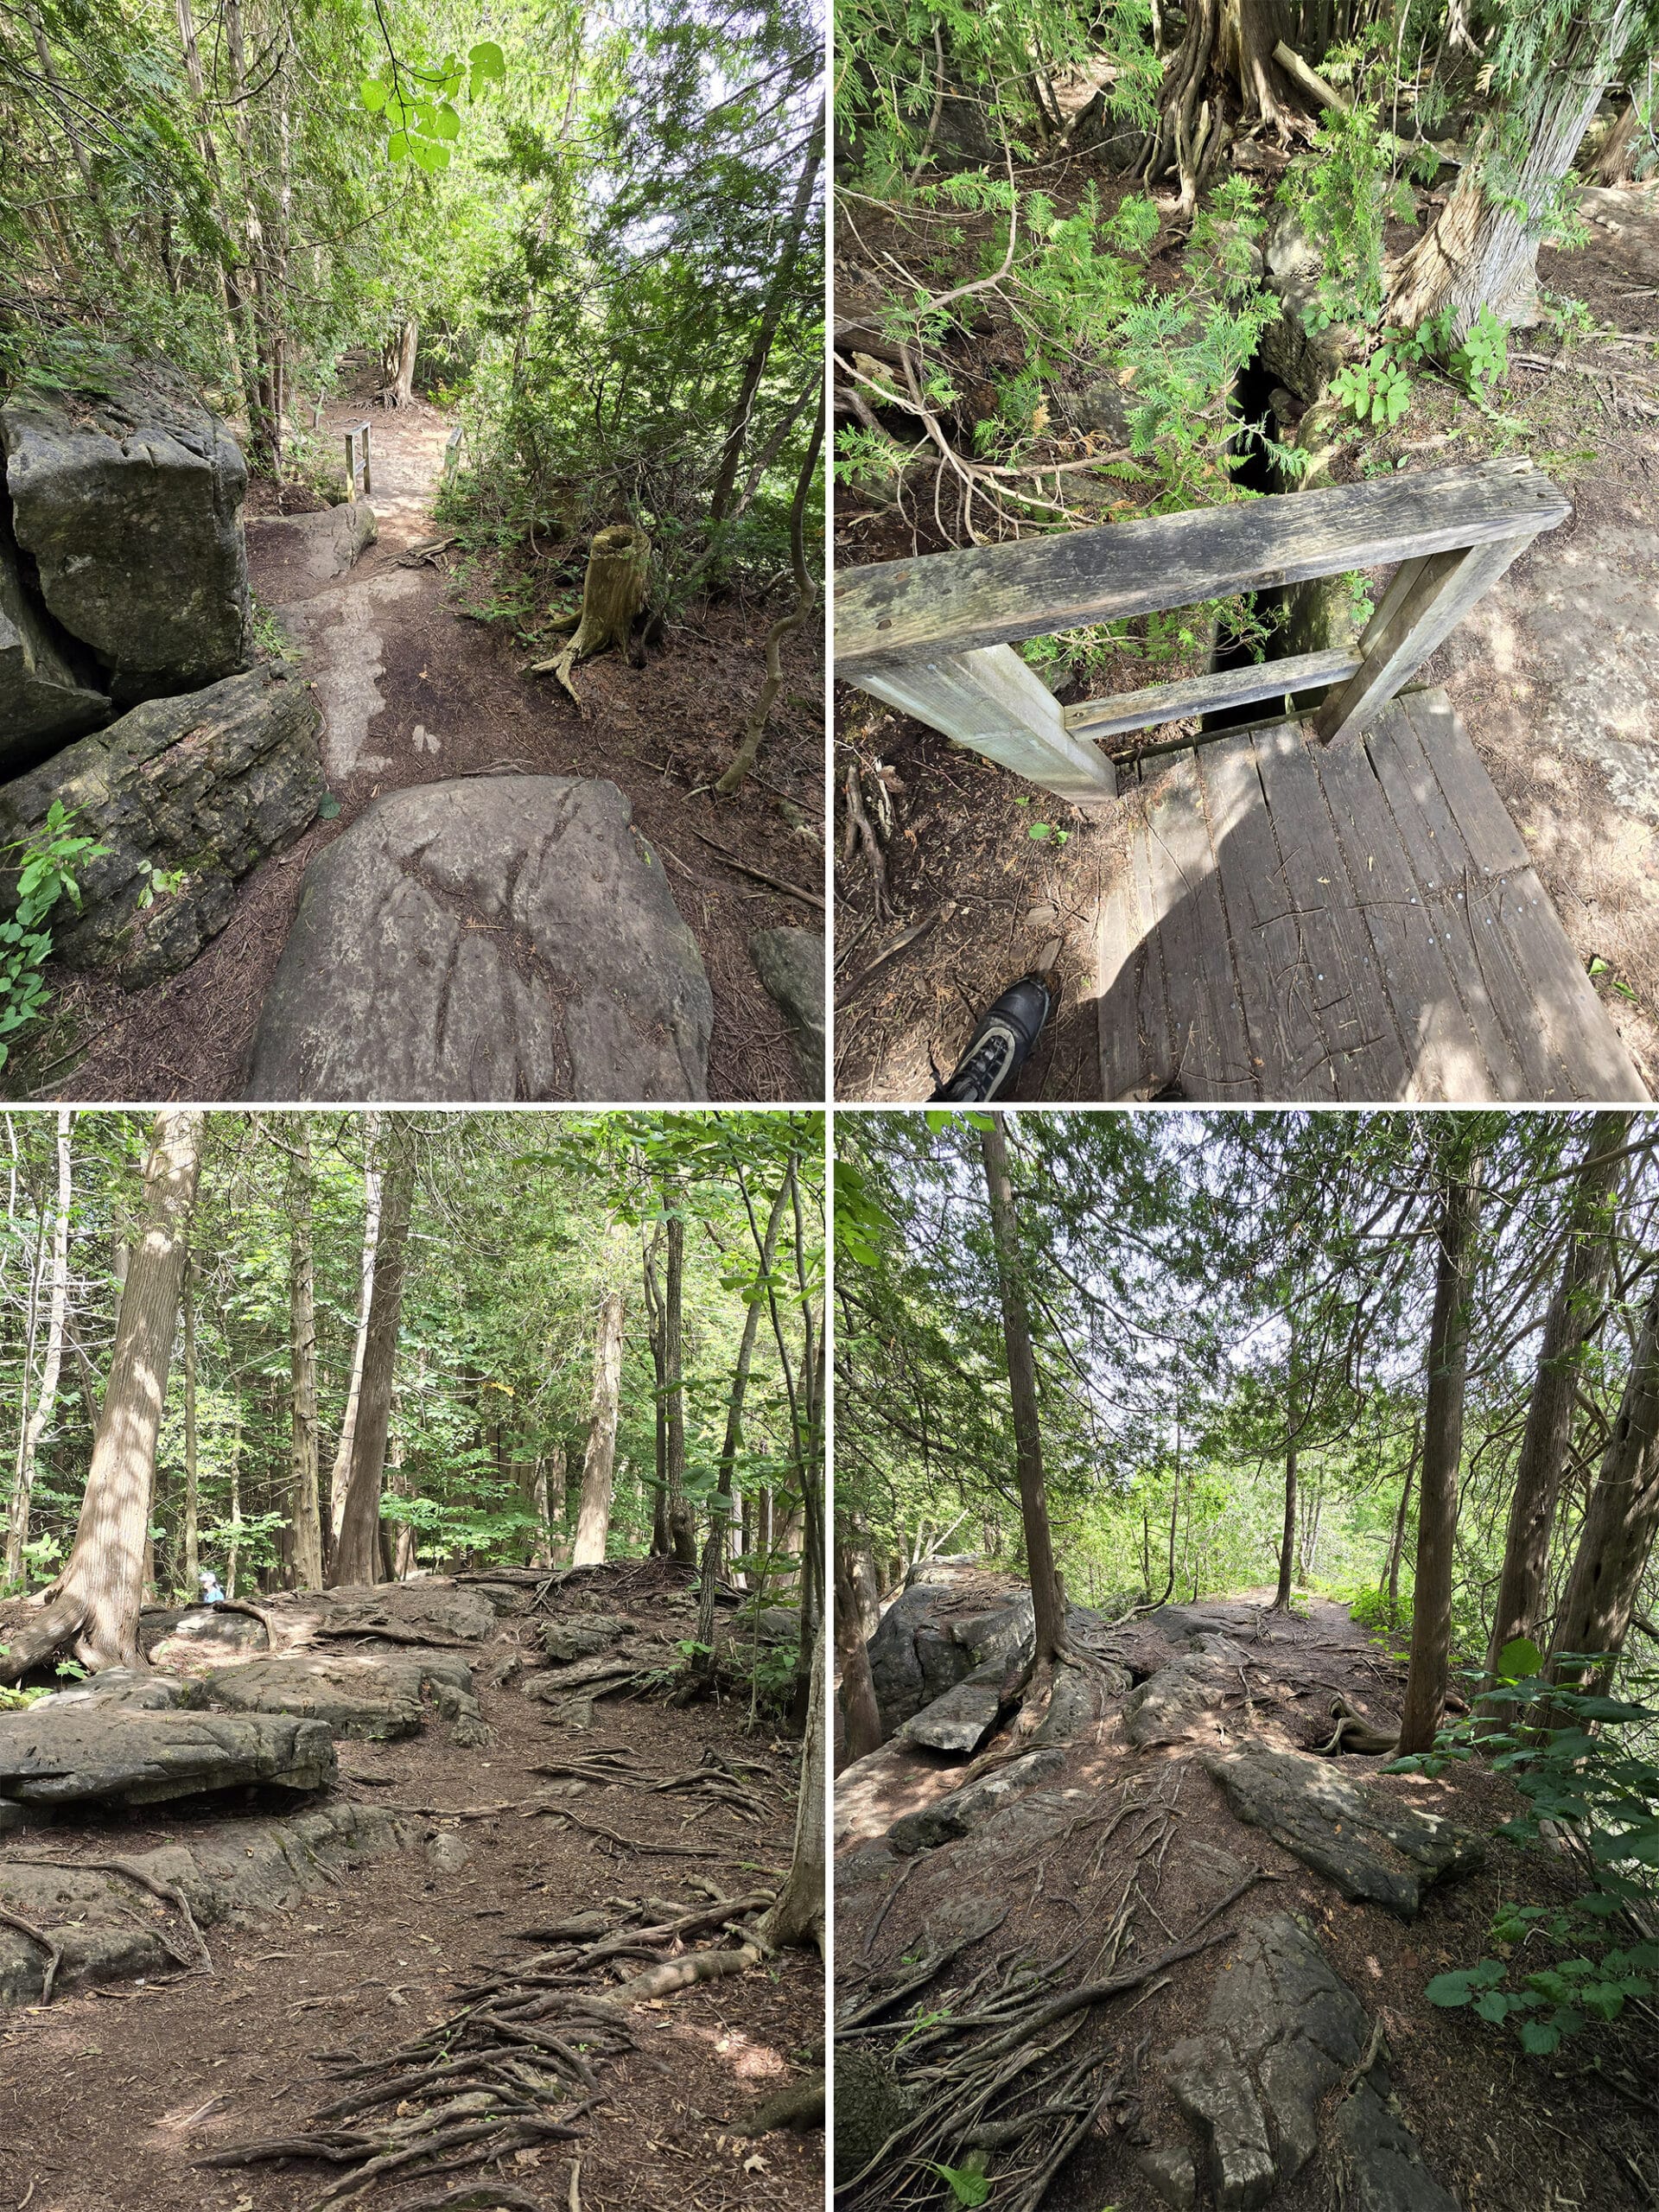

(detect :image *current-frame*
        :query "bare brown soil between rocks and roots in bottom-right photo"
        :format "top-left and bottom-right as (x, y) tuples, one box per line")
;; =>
(836, 1591), (1659, 2212)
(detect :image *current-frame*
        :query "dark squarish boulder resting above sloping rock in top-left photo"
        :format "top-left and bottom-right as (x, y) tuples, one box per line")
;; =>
(0, 365), (250, 706)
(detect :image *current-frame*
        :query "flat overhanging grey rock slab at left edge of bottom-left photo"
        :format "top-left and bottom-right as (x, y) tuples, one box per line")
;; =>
(0, 1697), (334, 1805)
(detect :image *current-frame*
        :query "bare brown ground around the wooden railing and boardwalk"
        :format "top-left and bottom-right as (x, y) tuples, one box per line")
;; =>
(836, 163), (1659, 1102)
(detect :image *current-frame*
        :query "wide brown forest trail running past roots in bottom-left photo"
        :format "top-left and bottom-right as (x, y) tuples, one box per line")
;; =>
(0, 1561), (823, 2212)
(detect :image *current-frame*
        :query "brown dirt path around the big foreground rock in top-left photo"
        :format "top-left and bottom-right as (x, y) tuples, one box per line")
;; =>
(48, 380), (823, 1099)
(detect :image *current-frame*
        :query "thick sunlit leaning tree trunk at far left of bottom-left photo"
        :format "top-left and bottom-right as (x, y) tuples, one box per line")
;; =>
(0, 1110), (204, 1681)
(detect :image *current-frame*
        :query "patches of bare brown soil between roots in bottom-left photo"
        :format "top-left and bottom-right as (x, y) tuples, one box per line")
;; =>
(0, 1568), (823, 2212)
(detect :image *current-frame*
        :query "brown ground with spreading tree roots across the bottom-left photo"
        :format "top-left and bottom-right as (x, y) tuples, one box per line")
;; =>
(0, 1561), (823, 2212)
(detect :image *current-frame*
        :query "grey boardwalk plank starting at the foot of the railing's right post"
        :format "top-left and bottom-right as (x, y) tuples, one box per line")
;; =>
(1319, 725), (1522, 1103)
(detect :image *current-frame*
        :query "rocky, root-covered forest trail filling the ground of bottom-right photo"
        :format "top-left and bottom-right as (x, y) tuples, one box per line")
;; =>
(836, 1571), (1656, 2212)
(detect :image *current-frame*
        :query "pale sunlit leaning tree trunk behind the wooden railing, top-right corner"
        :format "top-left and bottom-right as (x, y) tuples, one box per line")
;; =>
(1387, 0), (1637, 340)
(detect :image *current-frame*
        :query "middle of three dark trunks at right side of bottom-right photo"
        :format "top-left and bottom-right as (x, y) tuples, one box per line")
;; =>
(1486, 1113), (1630, 1679)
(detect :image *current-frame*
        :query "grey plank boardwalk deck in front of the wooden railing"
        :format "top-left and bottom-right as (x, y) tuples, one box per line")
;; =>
(1099, 690), (1648, 1103)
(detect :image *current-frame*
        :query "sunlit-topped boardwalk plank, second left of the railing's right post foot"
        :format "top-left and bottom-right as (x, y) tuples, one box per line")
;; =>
(1192, 736), (1340, 1099)
